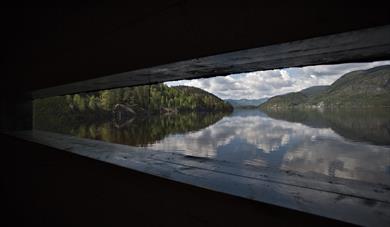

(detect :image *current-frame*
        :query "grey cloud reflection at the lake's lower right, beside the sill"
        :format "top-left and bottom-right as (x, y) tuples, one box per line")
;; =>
(281, 139), (390, 185)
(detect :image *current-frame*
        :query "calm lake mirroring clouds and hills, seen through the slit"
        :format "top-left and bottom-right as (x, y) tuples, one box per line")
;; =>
(35, 109), (390, 185)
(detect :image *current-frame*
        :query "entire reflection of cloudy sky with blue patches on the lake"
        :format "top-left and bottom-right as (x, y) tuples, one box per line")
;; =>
(150, 112), (390, 184)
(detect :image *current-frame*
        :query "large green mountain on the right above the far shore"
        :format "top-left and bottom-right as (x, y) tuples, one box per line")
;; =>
(260, 65), (390, 110)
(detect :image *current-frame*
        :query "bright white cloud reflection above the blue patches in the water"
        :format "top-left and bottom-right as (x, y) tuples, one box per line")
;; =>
(149, 111), (338, 157)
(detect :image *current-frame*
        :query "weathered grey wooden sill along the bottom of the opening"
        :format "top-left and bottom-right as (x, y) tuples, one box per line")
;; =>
(8, 130), (390, 226)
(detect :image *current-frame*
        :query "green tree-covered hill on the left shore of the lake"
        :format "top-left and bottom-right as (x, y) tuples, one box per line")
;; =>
(34, 84), (232, 129)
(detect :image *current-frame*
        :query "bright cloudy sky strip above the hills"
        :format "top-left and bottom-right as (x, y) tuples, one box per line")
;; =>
(165, 61), (390, 99)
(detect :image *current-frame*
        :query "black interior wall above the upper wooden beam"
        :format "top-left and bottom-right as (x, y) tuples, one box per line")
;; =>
(1, 0), (390, 90)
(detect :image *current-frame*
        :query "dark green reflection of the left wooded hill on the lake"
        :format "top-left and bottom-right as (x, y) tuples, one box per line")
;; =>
(37, 112), (227, 146)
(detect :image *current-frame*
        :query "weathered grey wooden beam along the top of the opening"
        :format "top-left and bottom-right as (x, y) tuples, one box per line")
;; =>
(32, 25), (390, 98)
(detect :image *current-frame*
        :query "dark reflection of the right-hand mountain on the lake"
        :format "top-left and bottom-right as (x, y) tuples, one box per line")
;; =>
(265, 109), (390, 145)
